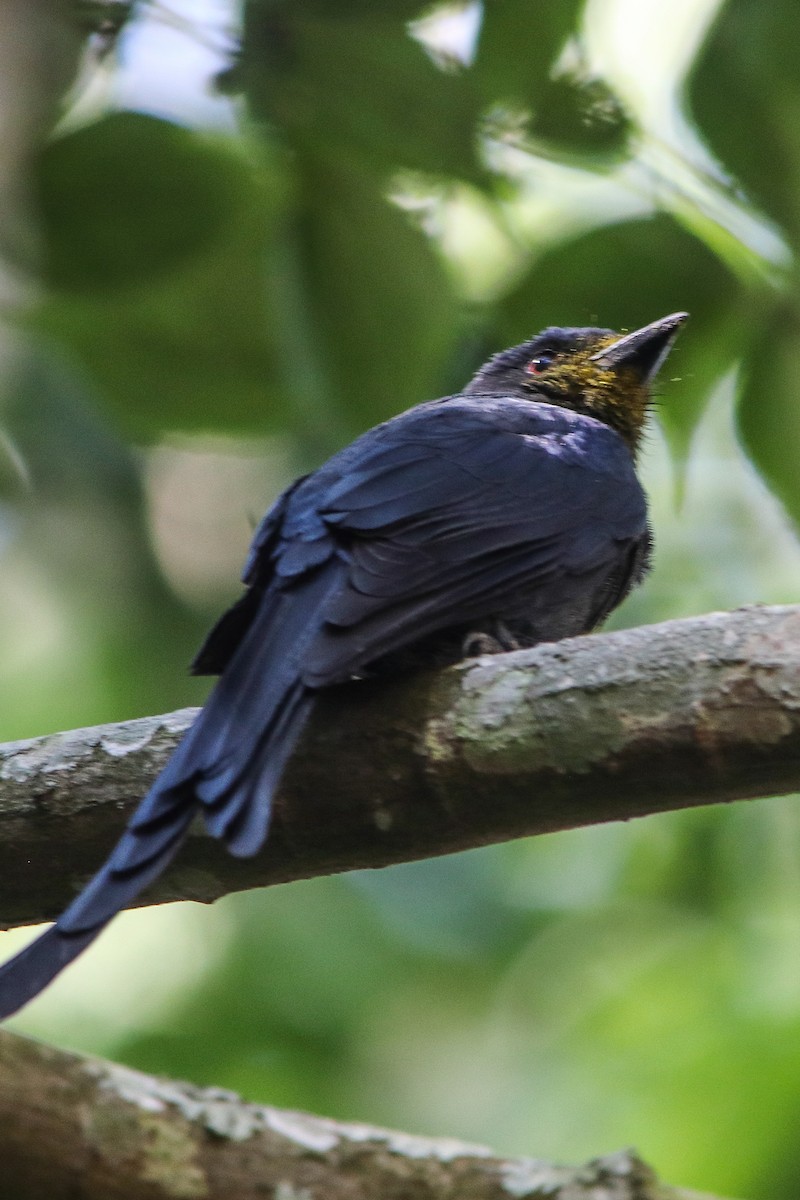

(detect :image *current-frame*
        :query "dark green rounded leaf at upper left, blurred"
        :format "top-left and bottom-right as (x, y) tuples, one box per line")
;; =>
(37, 113), (278, 293)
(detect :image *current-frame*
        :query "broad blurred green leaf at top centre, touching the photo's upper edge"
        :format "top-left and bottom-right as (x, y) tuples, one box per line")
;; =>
(233, 4), (479, 178)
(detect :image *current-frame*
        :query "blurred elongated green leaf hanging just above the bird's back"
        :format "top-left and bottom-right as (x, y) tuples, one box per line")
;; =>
(299, 157), (458, 428)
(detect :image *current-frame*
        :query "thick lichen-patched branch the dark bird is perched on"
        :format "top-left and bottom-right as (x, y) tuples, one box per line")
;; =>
(0, 606), (800, 924)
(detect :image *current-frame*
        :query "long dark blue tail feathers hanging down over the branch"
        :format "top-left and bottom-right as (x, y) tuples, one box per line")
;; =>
(0, 569), (335, 1019)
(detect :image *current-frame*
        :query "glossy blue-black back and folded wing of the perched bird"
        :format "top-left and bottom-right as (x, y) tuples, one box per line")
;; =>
(297, 400), (646, 686)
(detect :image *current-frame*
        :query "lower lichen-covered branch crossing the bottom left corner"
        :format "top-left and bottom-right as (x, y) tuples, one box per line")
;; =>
(0, 1033), (734, 1200)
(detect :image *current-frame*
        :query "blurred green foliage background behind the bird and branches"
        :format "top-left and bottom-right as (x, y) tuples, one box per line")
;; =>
(0, 0), (800, 1200)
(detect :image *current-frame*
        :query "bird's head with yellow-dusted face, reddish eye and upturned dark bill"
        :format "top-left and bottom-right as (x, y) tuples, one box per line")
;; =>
(464, 312), (688, 451)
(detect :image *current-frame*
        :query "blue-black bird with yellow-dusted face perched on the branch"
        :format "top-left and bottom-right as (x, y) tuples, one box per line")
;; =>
(0, 312), (687, 1018)
